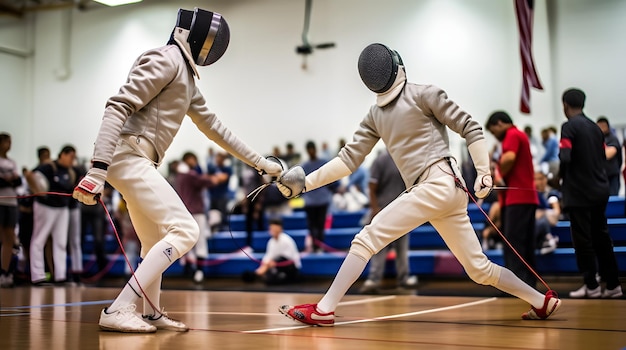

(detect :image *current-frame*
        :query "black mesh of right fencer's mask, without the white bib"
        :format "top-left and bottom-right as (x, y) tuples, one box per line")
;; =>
(358, 43), (402, 93)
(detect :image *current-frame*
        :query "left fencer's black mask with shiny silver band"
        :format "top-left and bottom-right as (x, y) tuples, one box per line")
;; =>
(187, 7), (230, 66)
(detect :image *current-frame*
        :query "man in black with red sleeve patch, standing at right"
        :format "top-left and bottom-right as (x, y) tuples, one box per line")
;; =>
(559, 88), (622, 298)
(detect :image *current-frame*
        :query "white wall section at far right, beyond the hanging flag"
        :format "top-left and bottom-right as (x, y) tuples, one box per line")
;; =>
(553, 0), (626, 125)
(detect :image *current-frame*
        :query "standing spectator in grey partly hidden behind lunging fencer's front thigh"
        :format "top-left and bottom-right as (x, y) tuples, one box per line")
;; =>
(360, 149), (417, 293)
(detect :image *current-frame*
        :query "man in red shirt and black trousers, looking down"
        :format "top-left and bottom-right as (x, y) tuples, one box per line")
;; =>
(486, 111), (538, 288)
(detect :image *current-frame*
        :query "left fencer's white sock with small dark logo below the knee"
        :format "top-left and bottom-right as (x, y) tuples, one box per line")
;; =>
(107, 240), (180, 313)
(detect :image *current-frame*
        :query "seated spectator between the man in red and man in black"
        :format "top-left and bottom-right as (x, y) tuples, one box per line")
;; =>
(535, 171), (561, 255)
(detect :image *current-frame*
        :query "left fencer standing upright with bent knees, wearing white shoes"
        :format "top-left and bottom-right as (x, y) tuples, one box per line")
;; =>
(73, 8), (282, 332)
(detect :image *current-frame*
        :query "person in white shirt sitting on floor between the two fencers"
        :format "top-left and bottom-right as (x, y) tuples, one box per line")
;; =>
(243, 218), (302, 285)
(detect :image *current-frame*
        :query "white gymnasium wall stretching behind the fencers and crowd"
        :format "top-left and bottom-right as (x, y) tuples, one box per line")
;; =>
(0, 0), (626, 172)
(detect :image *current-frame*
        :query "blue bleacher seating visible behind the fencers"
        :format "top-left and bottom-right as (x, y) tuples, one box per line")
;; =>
(83, 196), (626, 276)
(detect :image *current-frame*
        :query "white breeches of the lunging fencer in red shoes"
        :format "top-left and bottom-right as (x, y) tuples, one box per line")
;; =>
(350, 160), (501, 285)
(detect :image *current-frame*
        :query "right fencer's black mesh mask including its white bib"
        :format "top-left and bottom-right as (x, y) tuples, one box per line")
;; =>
(358, 43), (406, 107)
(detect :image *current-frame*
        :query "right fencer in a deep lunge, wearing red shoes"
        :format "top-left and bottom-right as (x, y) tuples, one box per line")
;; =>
(278, 43), (561, 326)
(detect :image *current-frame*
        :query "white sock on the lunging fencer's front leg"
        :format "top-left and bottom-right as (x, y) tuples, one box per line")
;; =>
(317, 253), (367, 313)
